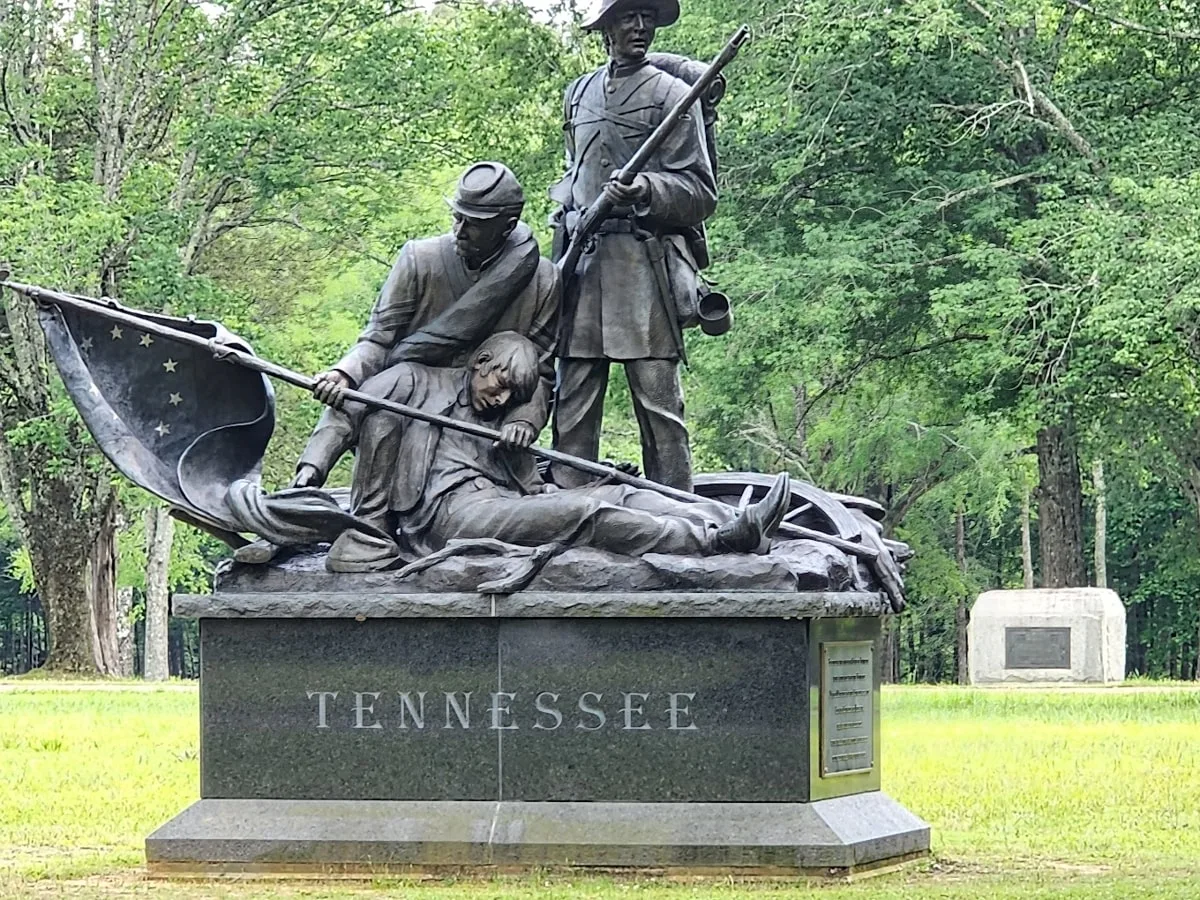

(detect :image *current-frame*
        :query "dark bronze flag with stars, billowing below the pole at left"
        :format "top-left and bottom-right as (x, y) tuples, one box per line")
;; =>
(46, 296), (275, 528)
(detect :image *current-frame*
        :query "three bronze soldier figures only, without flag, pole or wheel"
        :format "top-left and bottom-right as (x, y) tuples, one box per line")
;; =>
(239, 0), (790, 571)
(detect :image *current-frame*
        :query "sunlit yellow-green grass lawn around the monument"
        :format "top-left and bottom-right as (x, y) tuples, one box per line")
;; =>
(0, 680), (1200, 900)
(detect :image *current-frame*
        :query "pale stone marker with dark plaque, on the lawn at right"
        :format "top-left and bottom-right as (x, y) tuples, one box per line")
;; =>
(967, 588), (1126, 684)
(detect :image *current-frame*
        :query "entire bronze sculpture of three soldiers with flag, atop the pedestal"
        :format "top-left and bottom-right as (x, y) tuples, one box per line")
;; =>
(0, 0), (911, 611)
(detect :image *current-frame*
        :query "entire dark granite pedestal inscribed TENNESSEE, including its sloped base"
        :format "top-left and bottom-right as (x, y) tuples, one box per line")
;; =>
(146, 586), (929, 875)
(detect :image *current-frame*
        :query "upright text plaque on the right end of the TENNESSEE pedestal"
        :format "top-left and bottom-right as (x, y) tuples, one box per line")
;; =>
(821, 641), (875, 778)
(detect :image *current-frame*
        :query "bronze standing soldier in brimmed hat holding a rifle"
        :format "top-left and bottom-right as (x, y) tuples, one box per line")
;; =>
(550, 0), (716, 490)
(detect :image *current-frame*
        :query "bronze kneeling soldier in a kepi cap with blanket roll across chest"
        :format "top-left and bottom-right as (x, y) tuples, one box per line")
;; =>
(295, 162), (560, 492)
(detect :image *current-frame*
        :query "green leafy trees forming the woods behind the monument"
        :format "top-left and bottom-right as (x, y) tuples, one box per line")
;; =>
(0, 0), (1200, 680)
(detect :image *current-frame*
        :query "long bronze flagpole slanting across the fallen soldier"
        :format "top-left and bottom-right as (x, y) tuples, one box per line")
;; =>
(0, 280), (878, 560)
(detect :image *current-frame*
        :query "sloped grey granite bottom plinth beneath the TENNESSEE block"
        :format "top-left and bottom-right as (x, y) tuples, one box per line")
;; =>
(146, 791), (929, 877)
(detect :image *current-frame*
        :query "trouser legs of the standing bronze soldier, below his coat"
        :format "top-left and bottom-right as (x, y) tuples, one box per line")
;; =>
(553, 359), (691, 491)
